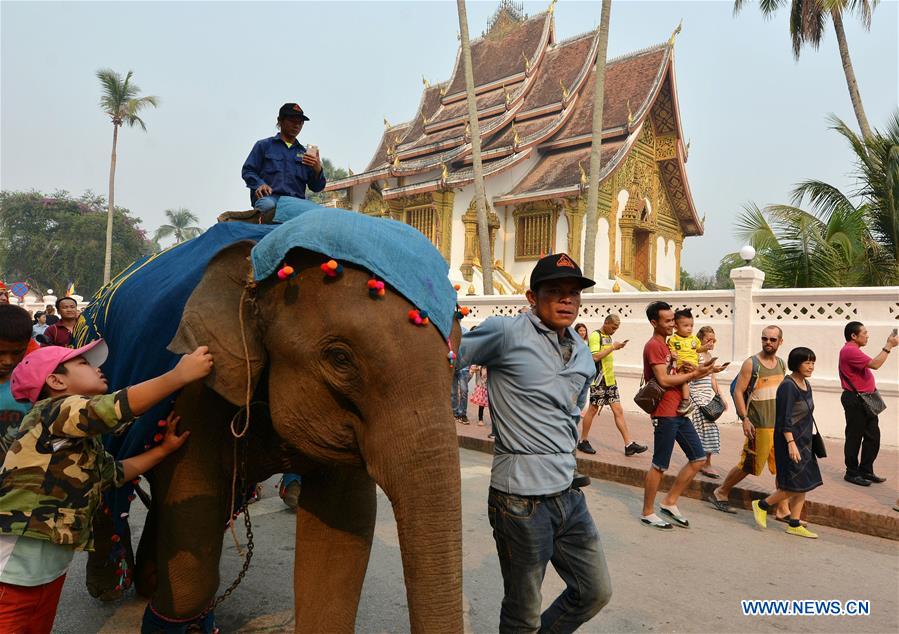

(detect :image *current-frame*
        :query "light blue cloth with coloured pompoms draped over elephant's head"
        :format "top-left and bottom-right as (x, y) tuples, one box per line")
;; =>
(252, 199), (456, 338)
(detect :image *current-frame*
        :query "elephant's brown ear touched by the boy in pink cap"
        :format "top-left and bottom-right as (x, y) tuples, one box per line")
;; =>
(168, 242), (266, 405)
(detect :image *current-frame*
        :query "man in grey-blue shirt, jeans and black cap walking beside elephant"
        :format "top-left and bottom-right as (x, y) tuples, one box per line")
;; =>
(460, 253), (612, 632)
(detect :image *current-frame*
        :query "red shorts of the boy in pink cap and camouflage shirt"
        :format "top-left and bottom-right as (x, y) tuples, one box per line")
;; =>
(0, 575), (66, 634)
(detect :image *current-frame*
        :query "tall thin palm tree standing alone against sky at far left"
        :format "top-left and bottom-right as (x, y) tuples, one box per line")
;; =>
(97, 68), (159, 284)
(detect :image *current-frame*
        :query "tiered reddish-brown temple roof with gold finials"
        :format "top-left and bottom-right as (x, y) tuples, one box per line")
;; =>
(327, 3), (702, 235)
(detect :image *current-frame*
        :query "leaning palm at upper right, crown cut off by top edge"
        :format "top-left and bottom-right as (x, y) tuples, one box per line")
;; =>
(734, 0), (880, 139)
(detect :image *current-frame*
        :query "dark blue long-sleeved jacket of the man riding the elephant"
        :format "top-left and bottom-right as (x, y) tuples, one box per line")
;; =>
(241, 134), (325, 198)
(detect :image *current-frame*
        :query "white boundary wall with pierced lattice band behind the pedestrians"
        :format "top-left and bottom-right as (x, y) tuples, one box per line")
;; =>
(459, 267), (899, 447)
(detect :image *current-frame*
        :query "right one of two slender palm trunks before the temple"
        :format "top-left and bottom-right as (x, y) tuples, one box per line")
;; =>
(583, 0), (612, 279)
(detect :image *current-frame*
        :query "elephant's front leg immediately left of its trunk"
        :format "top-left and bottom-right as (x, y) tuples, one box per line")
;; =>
(294, 467), (377, 632)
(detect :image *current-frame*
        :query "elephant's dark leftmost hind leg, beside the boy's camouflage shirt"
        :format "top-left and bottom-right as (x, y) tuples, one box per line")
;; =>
(84, 511), (134, 601)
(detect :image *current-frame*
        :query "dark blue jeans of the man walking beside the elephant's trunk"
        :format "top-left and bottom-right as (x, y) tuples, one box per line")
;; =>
(487, 487), (612, 633)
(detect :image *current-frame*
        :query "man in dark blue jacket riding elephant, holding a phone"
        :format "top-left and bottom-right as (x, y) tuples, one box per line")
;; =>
(241, 103), (325, 214)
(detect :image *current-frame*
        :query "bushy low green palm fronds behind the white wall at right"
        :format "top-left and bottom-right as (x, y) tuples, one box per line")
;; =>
(725, 112), (899, 288)
